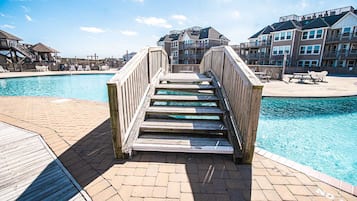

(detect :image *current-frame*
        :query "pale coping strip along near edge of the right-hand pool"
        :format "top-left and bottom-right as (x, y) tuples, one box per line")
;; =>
(255, 147), (357, 196)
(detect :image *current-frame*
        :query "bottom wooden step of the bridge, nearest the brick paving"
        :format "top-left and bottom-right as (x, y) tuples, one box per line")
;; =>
(132, 135), (233, 154)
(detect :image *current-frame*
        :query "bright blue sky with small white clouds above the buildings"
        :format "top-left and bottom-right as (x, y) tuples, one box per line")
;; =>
(0, 0), (357, 58)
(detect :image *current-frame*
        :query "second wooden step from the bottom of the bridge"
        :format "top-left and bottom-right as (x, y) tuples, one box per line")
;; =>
(140, 119), (227, 135)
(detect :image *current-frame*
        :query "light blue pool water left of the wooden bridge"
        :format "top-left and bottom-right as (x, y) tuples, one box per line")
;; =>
(0, 74), (113, 102)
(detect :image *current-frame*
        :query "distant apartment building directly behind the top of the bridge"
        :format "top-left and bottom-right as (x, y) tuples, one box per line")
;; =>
(157, 27), (229, 64)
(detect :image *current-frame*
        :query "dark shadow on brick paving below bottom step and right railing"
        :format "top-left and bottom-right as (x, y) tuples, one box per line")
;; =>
(133, 152), (252, 201)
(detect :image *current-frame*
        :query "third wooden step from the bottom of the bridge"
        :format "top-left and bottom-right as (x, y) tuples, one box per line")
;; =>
(146, 106), (224, 115)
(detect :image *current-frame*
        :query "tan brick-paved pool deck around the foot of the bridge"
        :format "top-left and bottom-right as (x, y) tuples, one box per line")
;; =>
(0, 71), (357, 201)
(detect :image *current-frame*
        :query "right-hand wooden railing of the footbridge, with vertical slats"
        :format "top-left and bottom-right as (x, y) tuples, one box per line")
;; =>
(200, 46), (263, 163)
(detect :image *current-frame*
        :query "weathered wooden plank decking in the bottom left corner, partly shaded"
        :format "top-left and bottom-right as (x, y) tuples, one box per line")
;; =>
(0, 122), (88, 200)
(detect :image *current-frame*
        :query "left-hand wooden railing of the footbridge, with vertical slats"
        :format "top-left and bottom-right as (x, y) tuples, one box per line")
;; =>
(107, 47), (169, 158)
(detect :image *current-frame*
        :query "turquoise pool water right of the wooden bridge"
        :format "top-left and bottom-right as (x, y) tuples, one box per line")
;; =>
(256, 97), (357, 186)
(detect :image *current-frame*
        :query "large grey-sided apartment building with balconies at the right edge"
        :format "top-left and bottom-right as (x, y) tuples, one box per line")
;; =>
(239, 6), (357, 73)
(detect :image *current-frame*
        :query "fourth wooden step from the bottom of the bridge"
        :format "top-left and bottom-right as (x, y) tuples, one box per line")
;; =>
(151, 95), (219, 102)
